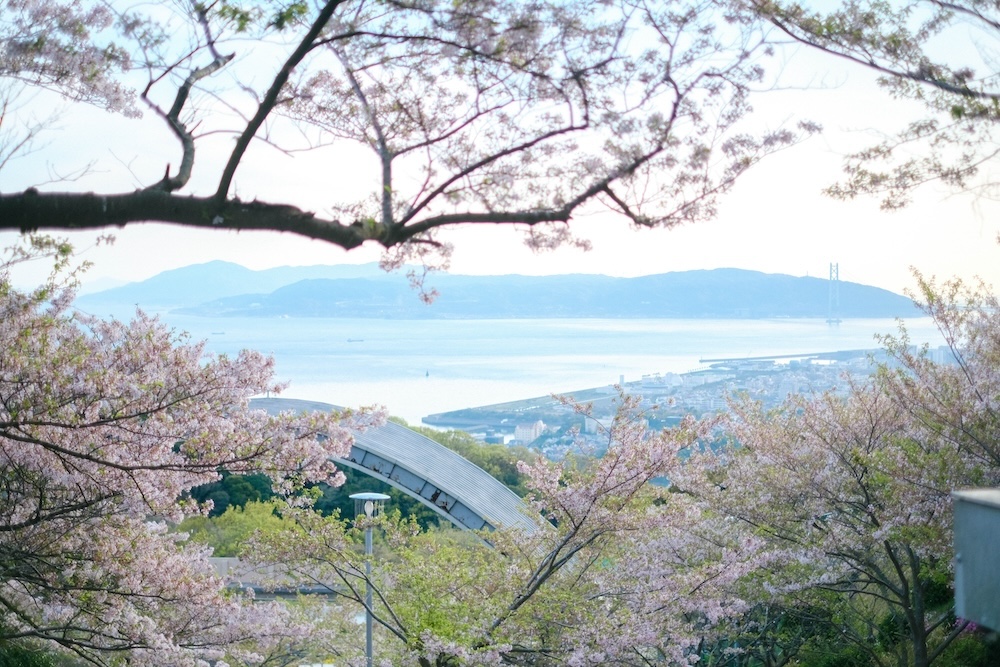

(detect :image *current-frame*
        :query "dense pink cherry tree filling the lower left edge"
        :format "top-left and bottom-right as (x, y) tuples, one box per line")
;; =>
(0, 237), (378, 665)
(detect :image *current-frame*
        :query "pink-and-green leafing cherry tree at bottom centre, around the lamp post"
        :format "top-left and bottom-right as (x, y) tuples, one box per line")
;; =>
(247, 398), (755, 667)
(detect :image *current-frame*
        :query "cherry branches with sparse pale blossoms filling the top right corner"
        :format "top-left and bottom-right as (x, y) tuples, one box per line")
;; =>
(751, 0), (1000, 209)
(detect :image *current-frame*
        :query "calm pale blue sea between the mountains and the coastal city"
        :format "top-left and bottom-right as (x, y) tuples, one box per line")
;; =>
(145, 314), (941, 423)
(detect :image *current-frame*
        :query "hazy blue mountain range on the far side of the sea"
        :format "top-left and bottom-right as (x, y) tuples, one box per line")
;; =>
(77, 261), (917, 319)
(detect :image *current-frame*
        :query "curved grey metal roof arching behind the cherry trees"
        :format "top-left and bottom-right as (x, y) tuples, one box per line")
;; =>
(250, 398), (538, 532)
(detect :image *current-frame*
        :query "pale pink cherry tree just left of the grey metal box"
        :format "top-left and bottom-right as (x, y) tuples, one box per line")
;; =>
(678, 380), (982, 667)
